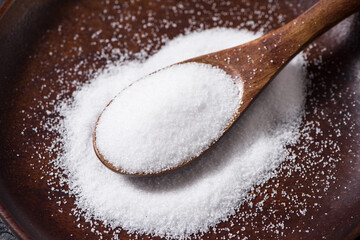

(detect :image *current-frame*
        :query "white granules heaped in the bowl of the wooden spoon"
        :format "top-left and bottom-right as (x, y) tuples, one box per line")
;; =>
(96, 63), (242, 173)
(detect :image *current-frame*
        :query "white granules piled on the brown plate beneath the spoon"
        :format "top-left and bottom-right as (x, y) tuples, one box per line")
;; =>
(57, 29), (305, 237)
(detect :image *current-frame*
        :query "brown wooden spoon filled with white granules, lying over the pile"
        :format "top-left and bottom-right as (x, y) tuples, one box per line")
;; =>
(93, 0), (360, 175)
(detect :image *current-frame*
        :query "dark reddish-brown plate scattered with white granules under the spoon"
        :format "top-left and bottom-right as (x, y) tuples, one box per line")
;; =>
(0, 0), (360, 239)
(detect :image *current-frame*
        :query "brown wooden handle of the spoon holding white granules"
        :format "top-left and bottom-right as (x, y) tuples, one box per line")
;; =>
(232, 0), (360, 106)
